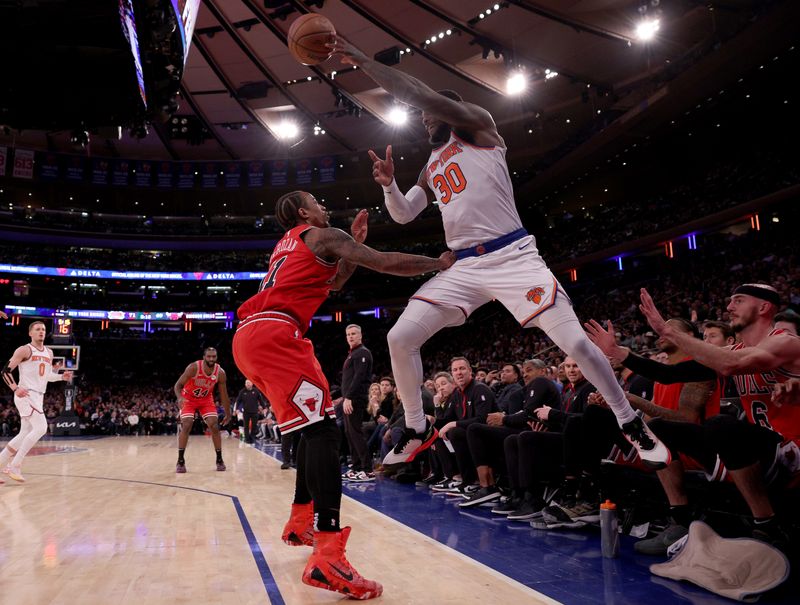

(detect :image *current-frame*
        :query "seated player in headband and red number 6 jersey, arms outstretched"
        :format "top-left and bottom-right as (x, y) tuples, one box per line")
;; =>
(640, 284), (800, 545)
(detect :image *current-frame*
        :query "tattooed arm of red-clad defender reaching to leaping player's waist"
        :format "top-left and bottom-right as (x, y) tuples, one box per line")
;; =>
(305, 227), (456, 282)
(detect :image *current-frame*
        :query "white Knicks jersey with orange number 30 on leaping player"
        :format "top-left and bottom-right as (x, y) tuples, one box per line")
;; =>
(425, 132), (522, 250)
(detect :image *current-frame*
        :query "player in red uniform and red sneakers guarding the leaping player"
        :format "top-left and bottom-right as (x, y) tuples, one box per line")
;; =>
(233, 191), (455, 599)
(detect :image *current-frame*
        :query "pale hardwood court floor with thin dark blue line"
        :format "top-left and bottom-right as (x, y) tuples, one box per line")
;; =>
(0, 436), (555, 605)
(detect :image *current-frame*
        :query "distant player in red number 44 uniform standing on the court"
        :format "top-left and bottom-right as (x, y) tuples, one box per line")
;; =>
(174, 347), (231, 473)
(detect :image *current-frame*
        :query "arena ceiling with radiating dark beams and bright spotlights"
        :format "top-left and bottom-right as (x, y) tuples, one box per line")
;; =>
(0, 0), (800, 201)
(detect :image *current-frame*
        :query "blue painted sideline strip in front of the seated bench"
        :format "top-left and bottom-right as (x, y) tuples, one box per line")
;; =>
(256, 438), (800, 605)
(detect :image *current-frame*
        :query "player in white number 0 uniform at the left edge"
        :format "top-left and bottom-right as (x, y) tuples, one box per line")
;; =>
(0, 321), (72, 483)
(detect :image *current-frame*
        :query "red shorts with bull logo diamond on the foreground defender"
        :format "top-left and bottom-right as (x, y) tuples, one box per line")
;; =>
(233, 311), (333, 435)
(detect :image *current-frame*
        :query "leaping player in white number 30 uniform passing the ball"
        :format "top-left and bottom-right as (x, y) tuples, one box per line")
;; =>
(329, 36), (669, 467)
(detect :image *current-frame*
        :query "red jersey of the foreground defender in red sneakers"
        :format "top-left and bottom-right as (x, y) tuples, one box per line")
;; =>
(237, 225), (339, 333)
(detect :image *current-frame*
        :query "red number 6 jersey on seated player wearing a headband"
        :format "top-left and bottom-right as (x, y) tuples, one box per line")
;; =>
(733, 330), (800, 442)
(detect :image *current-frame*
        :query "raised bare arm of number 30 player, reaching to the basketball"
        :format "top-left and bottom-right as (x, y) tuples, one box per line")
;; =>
(328, 36), (497, 132)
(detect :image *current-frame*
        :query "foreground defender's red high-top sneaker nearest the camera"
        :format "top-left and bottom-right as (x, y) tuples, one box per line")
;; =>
(303, 527), (383, 600)
